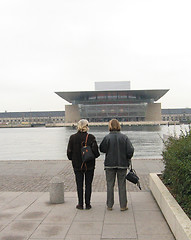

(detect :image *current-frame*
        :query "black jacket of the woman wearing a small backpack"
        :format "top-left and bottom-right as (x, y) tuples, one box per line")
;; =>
(67, 131), (100, 171)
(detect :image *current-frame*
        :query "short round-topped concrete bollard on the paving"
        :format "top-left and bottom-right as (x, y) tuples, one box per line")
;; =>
(49, 177), (64, 203)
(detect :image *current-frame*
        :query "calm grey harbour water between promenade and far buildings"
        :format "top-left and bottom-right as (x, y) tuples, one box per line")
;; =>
(0, 125), (188, 160)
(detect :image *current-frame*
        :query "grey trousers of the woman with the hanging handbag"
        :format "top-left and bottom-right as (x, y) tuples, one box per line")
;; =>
(105, 168), (127, 208)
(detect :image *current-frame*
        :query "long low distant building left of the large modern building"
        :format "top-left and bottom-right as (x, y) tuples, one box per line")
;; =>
(0, 111), (65, 125)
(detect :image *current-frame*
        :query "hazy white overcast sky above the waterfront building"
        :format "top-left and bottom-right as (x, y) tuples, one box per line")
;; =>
(0, 0), (191, 112)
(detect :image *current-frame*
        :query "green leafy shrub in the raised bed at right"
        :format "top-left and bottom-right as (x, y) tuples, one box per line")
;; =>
(162, 129), (191, 218)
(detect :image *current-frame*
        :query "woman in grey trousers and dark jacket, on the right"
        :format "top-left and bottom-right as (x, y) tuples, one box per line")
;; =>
(100, 119), (134, 211)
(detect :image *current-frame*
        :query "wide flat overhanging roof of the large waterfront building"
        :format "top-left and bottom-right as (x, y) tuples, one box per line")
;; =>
(56, 89), (169, 103)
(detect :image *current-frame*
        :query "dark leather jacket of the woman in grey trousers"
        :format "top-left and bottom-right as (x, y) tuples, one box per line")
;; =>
(100, 131), (134, 168)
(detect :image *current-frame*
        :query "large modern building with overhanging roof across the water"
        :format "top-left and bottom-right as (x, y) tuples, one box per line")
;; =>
(56, 81), (169, 123)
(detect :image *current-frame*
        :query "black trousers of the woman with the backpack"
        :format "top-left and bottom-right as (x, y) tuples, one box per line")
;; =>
(74, 169), (94, 206)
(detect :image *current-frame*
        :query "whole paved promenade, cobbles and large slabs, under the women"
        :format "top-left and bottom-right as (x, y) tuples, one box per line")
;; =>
(0, 159), (174, 240)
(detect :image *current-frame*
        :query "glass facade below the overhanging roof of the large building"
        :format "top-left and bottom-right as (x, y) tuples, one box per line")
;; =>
(79, 103), (147, 122)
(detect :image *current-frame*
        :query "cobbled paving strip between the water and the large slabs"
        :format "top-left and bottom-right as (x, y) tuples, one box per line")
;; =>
(0, 159), (163, 192)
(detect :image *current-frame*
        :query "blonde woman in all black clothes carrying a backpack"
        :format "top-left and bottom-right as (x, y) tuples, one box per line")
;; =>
(67, 119), (100, 209)
